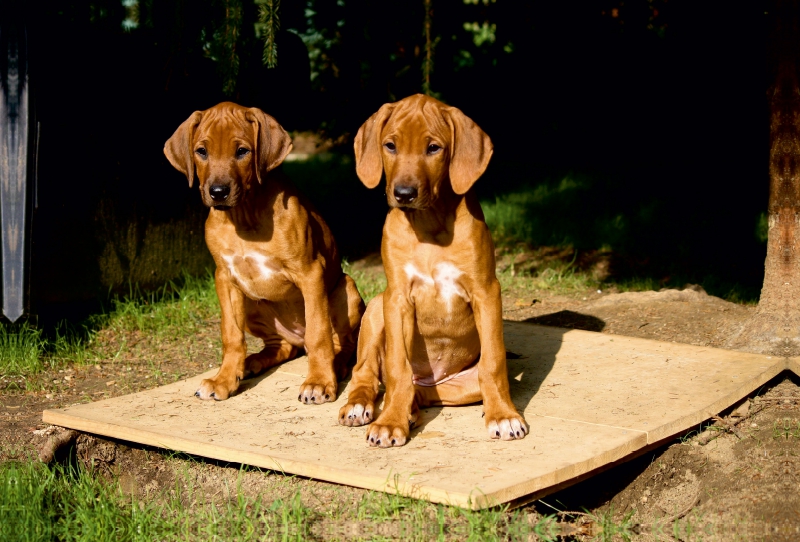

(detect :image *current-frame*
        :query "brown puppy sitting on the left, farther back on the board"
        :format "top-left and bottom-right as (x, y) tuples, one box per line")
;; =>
(164, 102), (364, 404)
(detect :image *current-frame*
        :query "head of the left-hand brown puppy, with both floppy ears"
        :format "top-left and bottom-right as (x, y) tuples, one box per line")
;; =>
(164, 102), (292, 210)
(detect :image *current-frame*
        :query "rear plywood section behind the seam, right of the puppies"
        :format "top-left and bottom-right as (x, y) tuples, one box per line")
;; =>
(506, 323), (786, 443)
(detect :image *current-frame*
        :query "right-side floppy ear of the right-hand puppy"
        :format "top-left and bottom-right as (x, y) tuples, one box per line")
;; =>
(443, 107), (494, 195)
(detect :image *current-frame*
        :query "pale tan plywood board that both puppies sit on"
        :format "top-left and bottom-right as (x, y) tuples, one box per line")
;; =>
(43, 322), (787, 508)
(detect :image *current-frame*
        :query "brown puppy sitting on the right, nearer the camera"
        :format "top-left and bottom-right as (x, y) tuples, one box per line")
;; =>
(339, 94), (528, 448)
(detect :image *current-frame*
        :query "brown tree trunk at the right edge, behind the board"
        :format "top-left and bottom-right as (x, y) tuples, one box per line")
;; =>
(729, 0), (800, 356)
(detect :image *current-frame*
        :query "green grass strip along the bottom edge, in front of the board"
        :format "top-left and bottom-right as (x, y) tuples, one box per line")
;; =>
(0, 462), (557, 542)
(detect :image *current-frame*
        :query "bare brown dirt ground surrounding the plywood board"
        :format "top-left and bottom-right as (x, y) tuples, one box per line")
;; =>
(0, 253), (800, 541)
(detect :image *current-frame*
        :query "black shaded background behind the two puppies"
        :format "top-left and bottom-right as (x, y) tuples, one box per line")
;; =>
(5, 0), (769, 316)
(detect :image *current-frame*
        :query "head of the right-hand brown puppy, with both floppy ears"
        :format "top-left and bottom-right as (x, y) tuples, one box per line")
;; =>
(354, 94), (493, 209)
